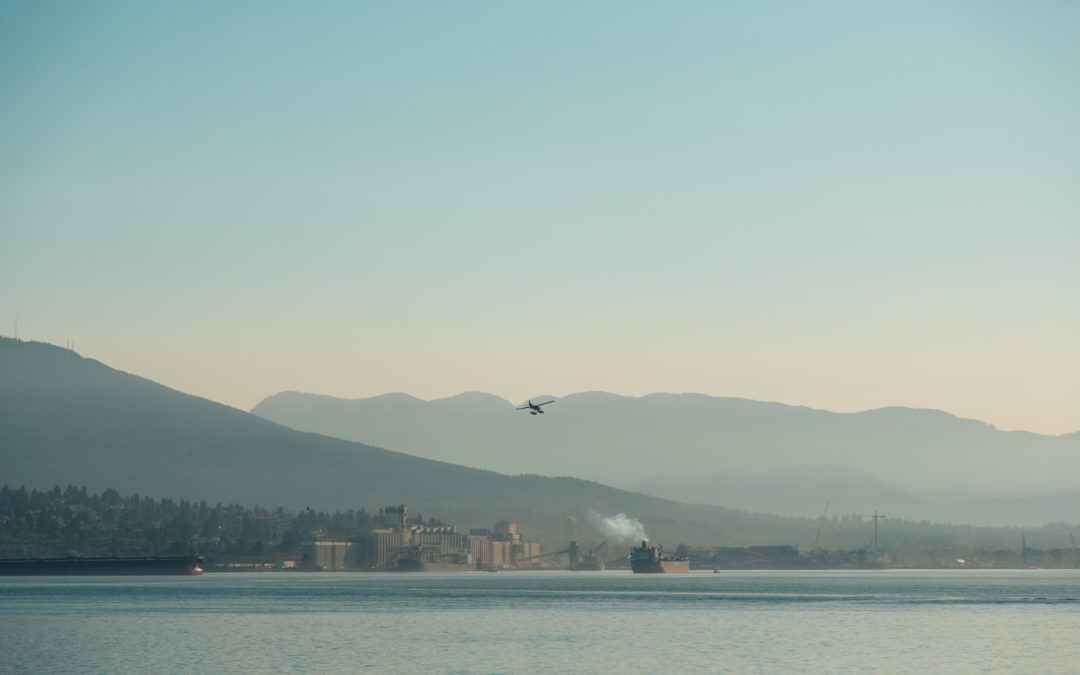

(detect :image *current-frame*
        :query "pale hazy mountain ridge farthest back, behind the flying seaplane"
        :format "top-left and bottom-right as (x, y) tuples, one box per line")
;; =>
(253, 392), (1080, 515)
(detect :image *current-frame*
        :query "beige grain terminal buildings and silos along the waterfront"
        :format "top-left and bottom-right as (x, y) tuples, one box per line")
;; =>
(303, 504), (540, 571)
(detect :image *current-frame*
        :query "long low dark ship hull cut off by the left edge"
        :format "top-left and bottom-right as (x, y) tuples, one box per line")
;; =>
(0, 555), (203, 577)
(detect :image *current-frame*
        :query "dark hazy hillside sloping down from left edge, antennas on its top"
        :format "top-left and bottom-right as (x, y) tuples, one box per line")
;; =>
(0, 338), (814, 544)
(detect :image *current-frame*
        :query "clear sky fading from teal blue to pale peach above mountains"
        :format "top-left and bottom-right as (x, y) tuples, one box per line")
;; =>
(0, 0), (1080, 434)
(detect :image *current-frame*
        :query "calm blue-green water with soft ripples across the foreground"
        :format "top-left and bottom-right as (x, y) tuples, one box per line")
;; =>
(0, 570), (1080, 673)
